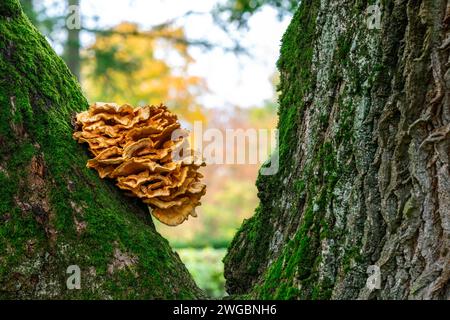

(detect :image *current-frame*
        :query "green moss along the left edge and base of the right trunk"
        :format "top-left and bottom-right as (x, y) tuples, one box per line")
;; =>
(225, 1), (336, 299)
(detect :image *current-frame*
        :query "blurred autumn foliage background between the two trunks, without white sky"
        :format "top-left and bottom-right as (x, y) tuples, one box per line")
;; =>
(21, 0), (298, 298)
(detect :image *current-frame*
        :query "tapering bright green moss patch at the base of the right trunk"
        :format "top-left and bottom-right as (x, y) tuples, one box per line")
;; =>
(251, 134), (341, 299)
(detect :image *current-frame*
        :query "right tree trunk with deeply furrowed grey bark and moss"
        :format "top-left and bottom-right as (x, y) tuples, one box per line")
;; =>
(225, 0), (450, 299)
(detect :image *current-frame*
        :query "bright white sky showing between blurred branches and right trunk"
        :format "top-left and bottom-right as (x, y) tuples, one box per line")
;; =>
(81, 0), (289, 107)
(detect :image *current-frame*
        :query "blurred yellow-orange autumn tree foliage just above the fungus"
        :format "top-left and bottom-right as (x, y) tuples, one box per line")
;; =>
(82, 23), (206, 122)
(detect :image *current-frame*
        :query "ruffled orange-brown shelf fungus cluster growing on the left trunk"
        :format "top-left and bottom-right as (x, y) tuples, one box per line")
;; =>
(74, 103), (206, 226)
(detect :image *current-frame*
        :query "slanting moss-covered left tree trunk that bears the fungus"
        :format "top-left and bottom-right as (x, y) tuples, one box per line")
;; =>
(0, 0), (202, 299)
